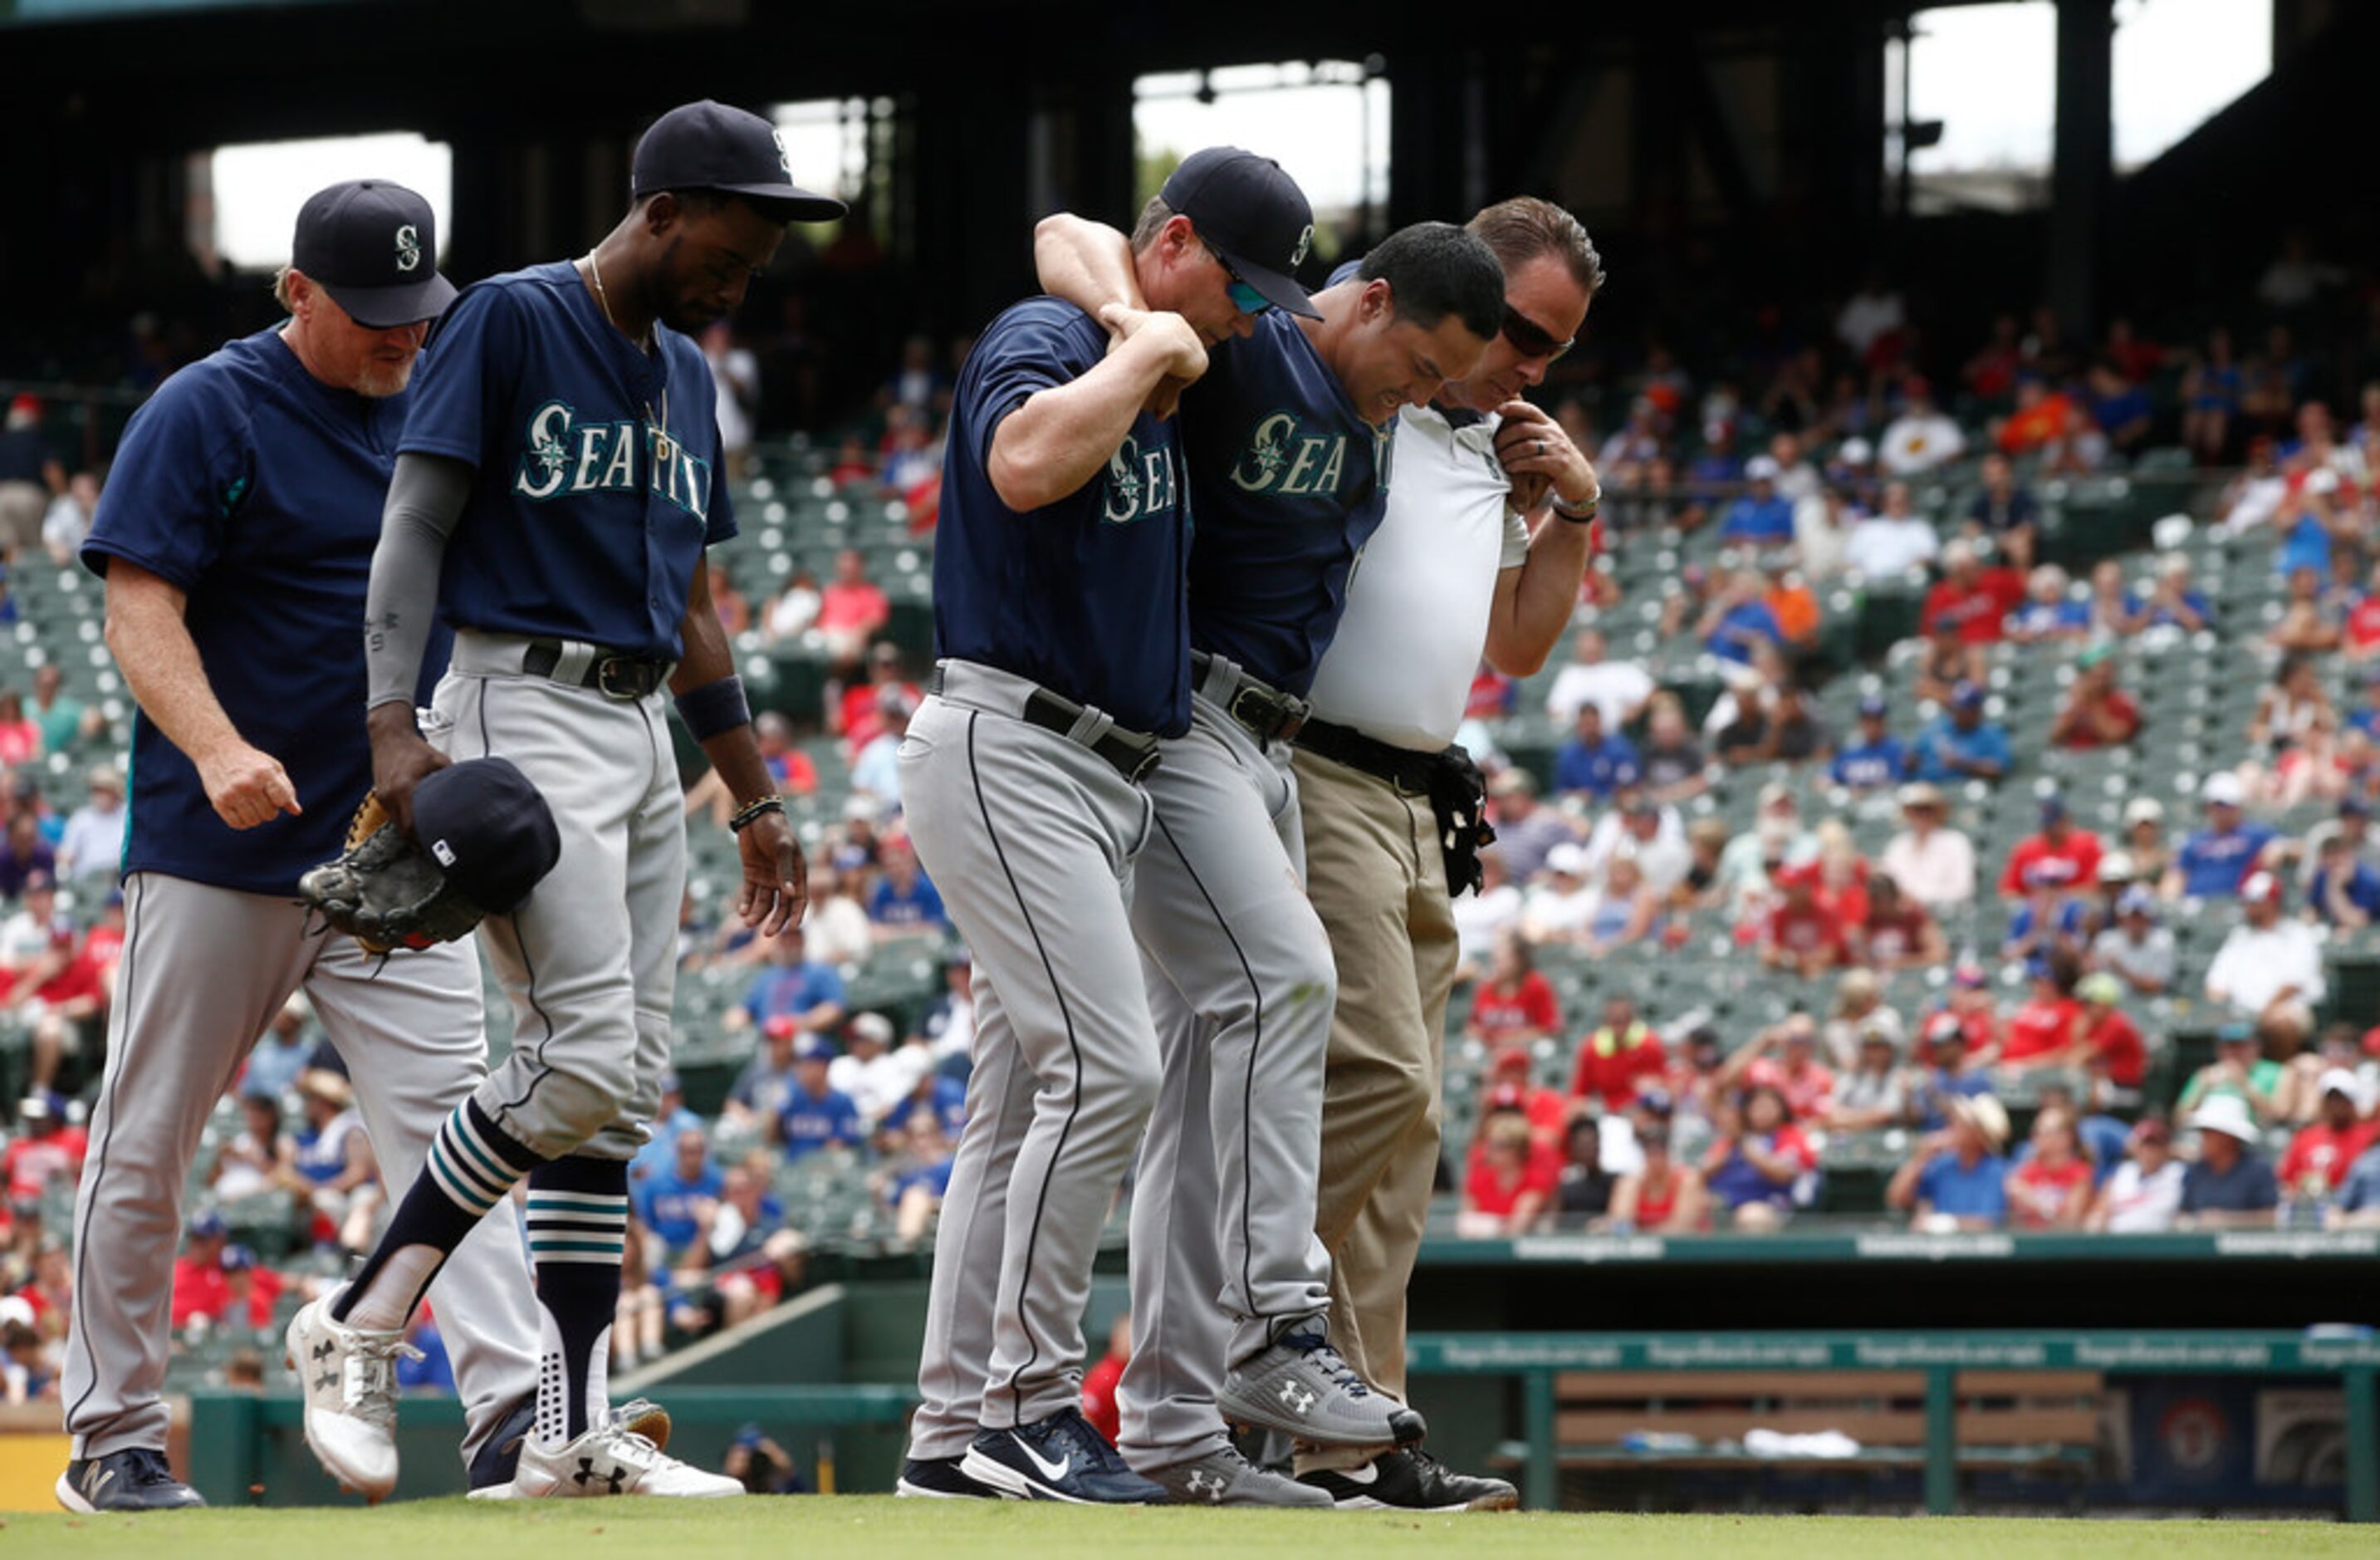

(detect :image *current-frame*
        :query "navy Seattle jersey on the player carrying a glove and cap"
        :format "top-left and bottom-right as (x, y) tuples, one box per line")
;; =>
(399, 260), (736, 660)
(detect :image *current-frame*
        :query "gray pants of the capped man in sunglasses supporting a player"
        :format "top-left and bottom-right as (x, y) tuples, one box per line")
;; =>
(899, 662), (1157, 1458)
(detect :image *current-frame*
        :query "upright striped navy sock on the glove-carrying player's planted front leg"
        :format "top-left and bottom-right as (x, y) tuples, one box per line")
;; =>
(528, 1155), (629, 1448)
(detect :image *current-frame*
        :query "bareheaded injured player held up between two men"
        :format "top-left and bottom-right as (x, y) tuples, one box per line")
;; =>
(1042, 179), (1504, 1505)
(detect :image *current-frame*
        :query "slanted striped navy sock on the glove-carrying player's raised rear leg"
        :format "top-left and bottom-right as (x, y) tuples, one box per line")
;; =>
(331, 1101), (541, 1332)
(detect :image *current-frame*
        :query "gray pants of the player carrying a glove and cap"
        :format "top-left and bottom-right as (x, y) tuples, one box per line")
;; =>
(426, 631), (685, 1160)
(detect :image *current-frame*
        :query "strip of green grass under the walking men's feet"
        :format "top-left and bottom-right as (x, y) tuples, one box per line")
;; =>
(0, 1496), (2380, 1560)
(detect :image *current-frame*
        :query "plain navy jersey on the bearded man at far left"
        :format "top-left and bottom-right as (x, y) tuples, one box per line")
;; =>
(83, 331), (448, 895)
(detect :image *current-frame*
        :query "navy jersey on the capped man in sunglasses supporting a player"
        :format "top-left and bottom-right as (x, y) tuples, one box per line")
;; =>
(933, 297), (1190, 736)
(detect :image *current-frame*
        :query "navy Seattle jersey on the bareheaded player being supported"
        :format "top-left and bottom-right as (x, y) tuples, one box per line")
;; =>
(1181, 310), (1394, 693)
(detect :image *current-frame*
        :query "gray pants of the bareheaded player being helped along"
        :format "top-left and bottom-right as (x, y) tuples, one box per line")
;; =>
(1119, 676), (1338, 1467)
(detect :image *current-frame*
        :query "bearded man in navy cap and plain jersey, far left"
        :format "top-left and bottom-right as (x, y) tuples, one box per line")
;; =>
(57, 181), (536, 1513)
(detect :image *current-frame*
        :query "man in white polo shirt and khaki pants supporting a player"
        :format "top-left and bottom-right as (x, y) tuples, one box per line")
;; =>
(1297, 198), (1604, 1510)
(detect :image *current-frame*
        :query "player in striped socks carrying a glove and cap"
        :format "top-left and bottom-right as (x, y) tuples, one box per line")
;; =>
(291, 102), (843, 1496)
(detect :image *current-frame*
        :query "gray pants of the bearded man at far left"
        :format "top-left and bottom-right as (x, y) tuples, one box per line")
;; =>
(62, 871), (538, 1460)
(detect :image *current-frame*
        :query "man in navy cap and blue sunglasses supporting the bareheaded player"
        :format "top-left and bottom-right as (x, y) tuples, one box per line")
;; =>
(899, 152), (1306, 1503)
